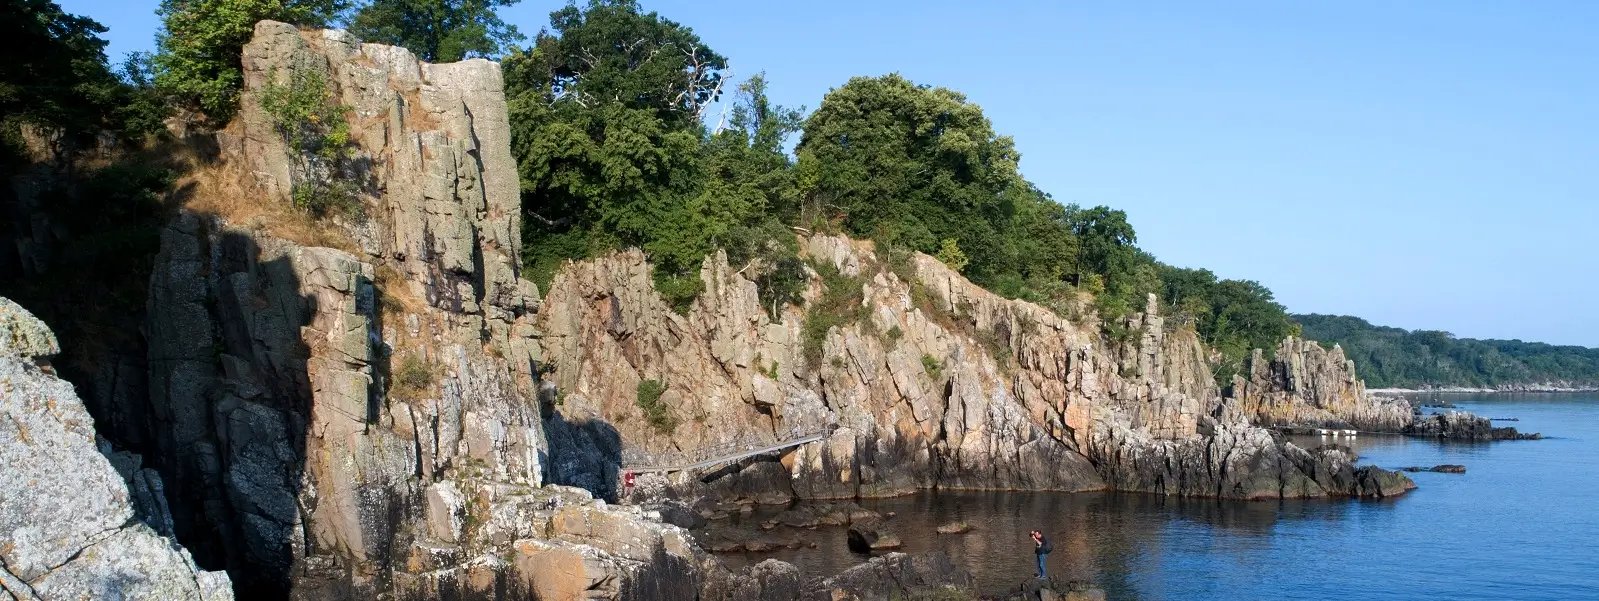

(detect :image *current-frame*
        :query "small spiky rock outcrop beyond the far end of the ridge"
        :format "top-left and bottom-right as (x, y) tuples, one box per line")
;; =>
(1233, 337), (1414, 432)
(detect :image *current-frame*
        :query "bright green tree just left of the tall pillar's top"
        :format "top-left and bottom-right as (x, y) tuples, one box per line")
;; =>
(155, 0), (349, 125)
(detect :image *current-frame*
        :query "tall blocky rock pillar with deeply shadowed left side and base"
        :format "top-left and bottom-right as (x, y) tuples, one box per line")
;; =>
(62, 21), (731, 599)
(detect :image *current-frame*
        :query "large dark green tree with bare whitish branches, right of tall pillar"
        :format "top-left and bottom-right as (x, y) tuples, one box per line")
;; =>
(505, 0), (732, 299)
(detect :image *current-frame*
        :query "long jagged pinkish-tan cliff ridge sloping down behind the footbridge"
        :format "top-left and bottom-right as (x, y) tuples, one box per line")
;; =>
(537, 237), (1409, 499)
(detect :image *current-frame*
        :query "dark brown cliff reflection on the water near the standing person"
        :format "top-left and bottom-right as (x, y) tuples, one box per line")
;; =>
(706, 491), (1381, 599)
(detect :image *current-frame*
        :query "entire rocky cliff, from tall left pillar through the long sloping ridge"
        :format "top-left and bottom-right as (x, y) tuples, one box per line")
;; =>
(0, 22), (1439, 601)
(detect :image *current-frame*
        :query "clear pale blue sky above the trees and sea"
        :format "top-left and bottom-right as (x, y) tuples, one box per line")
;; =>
(58, 0), (1599, 347)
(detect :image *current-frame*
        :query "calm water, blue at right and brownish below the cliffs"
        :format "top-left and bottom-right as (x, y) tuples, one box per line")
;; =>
(723, 395), (1599, 599)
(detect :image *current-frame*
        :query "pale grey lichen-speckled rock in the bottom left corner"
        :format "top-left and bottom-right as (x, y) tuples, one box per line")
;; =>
(0, 299), (233, 601)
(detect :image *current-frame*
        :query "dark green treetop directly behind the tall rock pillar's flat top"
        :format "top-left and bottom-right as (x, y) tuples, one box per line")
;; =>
(350, 0), (524, 62)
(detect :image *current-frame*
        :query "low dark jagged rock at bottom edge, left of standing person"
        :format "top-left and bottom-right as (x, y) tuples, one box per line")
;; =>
(803, 551), (975, 601)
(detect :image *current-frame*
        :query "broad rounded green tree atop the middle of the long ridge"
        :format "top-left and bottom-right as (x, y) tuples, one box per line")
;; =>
(798, 74), (1022, 283)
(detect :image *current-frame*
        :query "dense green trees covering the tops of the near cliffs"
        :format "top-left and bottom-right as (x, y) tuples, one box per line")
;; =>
(0, 0), (1298, 382)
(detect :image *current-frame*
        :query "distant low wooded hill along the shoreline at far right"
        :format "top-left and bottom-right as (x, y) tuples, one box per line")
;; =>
(1294, 315), (1599, 388)
